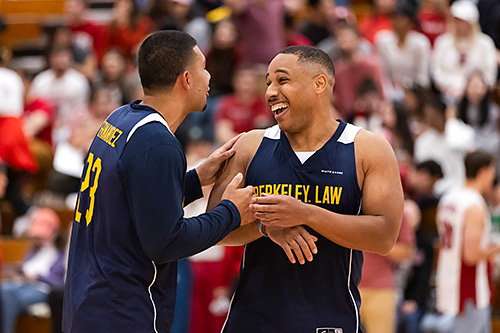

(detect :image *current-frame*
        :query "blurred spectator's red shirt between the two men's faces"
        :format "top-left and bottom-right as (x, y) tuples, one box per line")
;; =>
(215, 95), (271, 133)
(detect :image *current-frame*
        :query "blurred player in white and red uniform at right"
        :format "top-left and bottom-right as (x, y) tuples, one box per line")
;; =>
(436, 151), (500, 333)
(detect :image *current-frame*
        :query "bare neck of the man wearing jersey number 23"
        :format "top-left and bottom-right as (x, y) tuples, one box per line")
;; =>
(141, 94), (187, 133)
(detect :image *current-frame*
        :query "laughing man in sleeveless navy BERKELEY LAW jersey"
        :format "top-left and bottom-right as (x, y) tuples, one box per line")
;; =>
(209, 46), (403, 333)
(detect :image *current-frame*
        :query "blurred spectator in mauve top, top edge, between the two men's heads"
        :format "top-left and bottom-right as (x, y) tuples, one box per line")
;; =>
(224, 0), (285, 66)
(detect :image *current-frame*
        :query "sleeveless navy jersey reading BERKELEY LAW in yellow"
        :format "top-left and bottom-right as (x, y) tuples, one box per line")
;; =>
(223, 121), (363, 333)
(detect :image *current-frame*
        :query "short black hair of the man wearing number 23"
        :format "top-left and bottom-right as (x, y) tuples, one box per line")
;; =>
(137, 30), (196, 92)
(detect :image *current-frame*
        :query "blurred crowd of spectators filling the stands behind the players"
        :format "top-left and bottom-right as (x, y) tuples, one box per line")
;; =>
(0, 0), (500, 333)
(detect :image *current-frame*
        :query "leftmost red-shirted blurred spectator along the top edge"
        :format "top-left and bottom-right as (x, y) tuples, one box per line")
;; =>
(64, 0), (107, 61)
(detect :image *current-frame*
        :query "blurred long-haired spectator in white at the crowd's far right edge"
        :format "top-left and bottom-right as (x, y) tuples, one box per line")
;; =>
(457, 71), (500, 163)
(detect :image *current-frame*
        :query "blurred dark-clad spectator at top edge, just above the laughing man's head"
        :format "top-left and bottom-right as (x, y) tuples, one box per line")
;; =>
(300, 0), (335, 45)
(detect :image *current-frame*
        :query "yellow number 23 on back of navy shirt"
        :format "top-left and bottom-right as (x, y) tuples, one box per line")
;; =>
(75, 153), (102, 226)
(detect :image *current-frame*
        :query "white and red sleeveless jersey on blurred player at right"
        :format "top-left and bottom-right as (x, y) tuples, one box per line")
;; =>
(436, 188), (491, 315)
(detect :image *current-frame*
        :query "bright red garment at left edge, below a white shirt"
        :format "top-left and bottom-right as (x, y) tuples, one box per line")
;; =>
(0, 117), (38, 172)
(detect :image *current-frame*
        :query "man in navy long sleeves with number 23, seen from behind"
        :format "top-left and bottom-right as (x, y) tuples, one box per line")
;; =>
(63, 31), (254, 333)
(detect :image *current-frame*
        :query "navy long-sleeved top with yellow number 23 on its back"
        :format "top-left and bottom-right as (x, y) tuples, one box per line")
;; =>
(63, 102), (240, 332)
